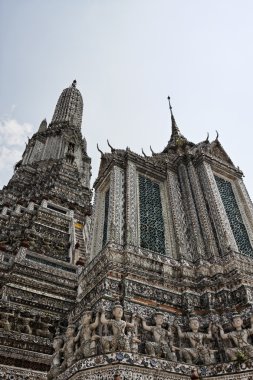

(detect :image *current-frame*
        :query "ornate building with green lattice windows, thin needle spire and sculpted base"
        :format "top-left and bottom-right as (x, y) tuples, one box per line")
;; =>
(59, 97), (253, 380)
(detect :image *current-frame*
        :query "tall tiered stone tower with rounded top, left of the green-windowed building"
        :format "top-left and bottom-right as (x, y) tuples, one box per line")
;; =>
(0, 81), (91, 379)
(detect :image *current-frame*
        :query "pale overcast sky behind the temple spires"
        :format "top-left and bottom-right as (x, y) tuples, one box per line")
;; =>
(0, 0), (253, 197)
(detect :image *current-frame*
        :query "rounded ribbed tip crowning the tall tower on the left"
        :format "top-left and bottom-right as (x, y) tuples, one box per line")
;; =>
(52, 80), (83, 128)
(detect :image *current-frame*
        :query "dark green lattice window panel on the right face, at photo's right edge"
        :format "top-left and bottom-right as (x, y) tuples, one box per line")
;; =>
(215, 176), (253, 256)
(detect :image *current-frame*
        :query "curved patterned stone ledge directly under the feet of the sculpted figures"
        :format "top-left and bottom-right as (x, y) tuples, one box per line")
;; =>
(57, 352), (253, 380)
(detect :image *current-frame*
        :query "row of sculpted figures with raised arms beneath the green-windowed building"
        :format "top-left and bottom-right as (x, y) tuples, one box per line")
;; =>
(48, 304), (253, 379)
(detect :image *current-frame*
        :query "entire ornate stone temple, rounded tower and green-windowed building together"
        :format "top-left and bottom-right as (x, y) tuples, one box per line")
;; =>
(0, 81), (253, 380)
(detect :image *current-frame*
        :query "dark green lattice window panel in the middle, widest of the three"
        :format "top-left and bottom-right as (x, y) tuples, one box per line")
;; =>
(139, 175), (165, 254)
